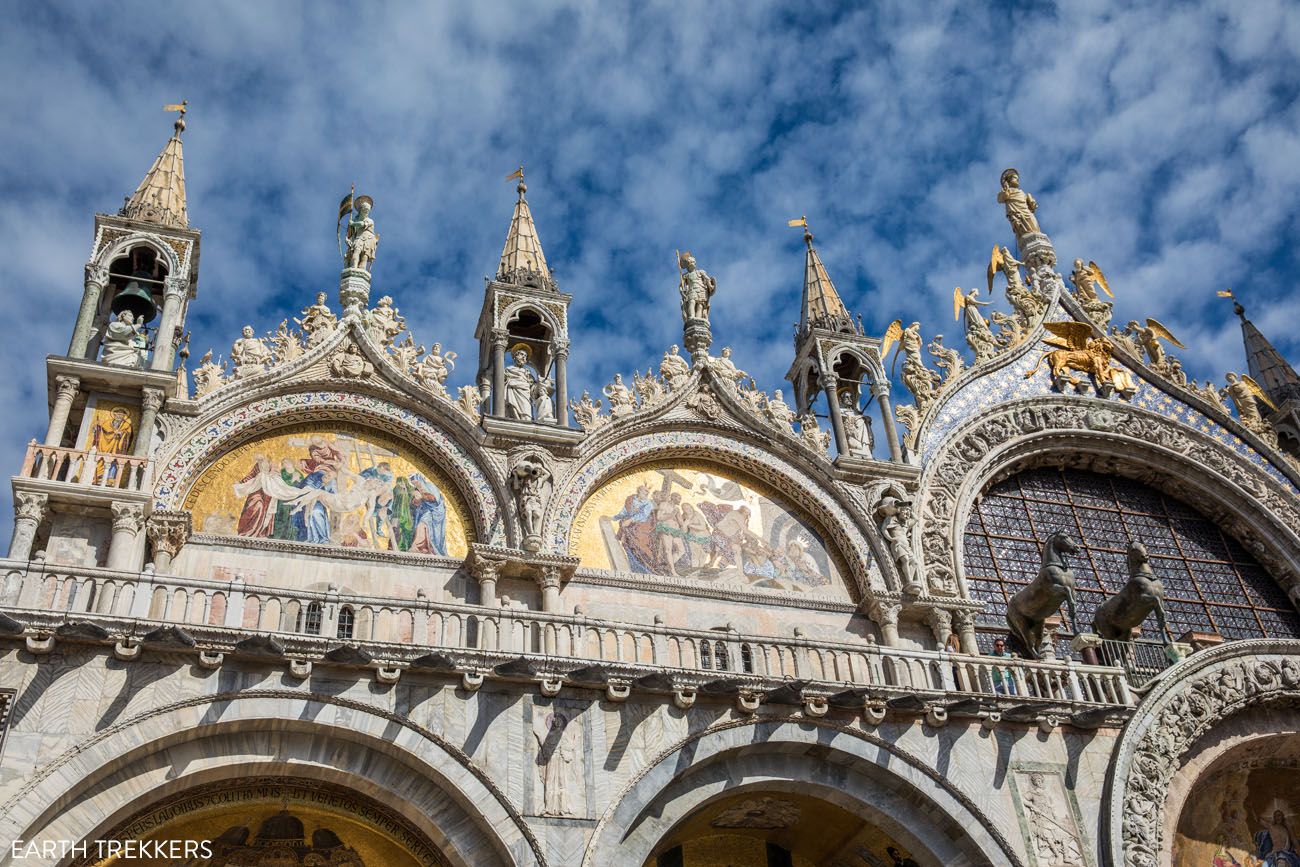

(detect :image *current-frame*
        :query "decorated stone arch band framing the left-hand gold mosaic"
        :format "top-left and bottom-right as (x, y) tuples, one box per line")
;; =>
(153, 383), (510, 545)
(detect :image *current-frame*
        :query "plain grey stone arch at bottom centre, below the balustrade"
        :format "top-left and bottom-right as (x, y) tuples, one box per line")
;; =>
(582, 718), (1024, 867)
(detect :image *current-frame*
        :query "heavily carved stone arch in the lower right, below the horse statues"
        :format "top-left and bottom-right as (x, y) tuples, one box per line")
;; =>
(1101, 638), (1300, 867)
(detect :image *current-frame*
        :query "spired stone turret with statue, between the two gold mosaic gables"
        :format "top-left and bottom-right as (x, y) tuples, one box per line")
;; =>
(475, 166), (572, 438)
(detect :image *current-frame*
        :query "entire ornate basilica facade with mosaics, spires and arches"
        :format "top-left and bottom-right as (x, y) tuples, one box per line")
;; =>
(0, 108), (1300, 867)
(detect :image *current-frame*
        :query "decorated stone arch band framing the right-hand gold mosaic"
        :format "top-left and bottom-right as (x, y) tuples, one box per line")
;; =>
(543, 429), (885, 602)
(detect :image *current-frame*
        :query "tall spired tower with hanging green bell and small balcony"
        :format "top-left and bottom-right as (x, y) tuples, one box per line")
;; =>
(9, 103), (199, 571)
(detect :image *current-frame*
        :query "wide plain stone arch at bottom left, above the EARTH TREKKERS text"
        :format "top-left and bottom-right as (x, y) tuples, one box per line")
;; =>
(0, 689), (545, 866)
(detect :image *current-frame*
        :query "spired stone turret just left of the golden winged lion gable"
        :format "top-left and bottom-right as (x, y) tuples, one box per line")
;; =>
(785, 217), (902, 460)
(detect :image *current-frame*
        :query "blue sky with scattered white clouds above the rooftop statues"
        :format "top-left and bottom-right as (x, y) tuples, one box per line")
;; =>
(0, 0), (1300, 532)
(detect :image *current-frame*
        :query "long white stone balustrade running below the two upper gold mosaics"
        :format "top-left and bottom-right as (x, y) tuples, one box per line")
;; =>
(0, 560), (1134, 706)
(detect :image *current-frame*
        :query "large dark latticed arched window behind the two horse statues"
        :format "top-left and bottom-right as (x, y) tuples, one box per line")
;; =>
(965, 469), (1300, 640)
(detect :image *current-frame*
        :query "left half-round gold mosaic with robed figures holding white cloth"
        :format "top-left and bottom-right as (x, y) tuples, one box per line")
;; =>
(185, 425), (472, 558)
